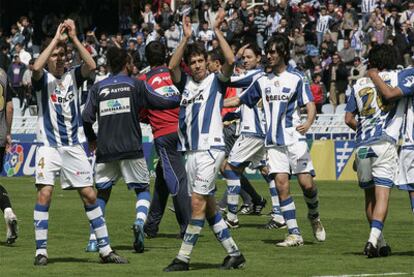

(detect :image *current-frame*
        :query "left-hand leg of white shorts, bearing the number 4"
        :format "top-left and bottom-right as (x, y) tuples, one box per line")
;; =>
(35, 146), (62, 185)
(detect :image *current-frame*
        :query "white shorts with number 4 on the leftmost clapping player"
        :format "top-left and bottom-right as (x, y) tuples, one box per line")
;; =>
(36, 144), (93, 189)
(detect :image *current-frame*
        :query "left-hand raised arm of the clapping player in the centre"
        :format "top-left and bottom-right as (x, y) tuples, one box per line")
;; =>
(168, 16), (192, 83)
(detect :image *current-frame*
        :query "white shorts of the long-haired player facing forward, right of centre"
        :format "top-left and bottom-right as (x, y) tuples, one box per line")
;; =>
(267, 141), (315, 176)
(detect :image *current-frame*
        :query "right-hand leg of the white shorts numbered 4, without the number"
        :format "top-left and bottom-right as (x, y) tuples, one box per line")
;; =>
(59, 144), (93, 189)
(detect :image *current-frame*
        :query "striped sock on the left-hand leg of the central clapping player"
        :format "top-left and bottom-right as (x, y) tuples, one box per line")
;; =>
(177, 219), (204, 263)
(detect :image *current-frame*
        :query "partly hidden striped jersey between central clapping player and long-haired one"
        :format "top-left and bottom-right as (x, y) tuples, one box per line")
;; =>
(229, 69), (266, 138)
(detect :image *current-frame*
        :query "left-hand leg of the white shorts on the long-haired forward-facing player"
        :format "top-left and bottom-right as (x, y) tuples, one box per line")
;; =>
(266, 146), (291, 174)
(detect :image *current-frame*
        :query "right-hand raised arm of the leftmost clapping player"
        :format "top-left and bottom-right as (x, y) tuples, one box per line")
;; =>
(64, 19), (96, 78)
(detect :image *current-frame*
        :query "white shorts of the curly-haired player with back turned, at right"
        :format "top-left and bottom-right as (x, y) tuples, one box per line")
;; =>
(355, 141), (398, 189)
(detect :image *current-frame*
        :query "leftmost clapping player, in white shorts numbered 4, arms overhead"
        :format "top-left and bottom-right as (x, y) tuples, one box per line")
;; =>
(32, 19), (128, 265)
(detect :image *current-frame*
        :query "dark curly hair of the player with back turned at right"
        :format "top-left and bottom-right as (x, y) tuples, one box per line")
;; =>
(368, 44), (397, 70)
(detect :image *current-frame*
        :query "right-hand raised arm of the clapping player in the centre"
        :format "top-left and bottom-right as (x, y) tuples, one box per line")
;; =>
(214, 8), (234, 78)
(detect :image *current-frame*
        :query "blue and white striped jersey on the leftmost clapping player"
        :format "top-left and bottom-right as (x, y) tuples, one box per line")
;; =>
(32, 66), (86, 147)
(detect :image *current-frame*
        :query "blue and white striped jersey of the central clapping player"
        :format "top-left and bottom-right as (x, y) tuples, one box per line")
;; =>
(177, 73), (226, 151)
